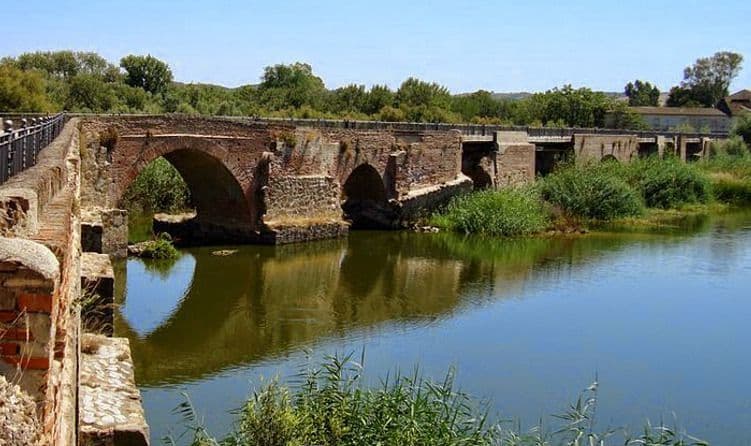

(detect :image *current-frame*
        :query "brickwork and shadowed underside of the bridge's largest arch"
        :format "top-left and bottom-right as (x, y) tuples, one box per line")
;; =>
(111, 136), (257, 229)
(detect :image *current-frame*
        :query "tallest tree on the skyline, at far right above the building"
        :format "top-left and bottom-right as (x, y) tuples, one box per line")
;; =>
(668, 51), (743, 107)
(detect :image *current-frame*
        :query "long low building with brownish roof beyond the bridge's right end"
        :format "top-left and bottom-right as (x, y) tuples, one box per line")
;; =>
(630, 107), (731, 132)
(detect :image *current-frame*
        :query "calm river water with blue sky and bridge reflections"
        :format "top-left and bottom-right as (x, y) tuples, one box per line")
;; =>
(116, 213), (751, 445)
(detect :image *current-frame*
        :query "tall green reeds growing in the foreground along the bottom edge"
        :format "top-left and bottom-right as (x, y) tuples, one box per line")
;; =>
(173, 356), (706, 446)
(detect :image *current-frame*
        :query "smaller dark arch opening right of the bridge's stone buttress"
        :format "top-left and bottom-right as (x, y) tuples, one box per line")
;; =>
(342, 164), (398, 229)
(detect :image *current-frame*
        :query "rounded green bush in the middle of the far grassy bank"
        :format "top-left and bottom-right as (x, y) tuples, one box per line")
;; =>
(541, 162), (644, 221)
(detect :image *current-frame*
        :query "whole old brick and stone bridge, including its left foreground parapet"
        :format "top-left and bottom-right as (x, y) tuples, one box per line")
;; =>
(0, 115), (728, 445)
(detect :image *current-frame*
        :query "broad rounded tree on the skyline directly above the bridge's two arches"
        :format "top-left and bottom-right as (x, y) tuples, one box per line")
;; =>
(258, 62), (326, 110)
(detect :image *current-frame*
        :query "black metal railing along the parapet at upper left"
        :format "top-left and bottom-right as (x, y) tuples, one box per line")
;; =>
(0, 113), (65, 184)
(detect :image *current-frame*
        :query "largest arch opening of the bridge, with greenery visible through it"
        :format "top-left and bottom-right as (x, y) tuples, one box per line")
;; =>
(120, 149), (254, 245)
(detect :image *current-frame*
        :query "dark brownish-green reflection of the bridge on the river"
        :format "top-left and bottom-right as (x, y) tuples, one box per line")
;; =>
(116, 217), (720, 385)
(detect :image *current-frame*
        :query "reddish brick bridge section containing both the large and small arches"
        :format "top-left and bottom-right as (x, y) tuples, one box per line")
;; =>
(82, 116), (470, 244)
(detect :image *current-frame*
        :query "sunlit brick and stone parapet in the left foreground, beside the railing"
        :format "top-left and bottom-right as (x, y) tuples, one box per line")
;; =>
(0, 120), (80, 444)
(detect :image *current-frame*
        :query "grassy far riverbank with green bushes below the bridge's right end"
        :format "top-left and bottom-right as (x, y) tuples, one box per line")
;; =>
(430, 152), (751, 236)
